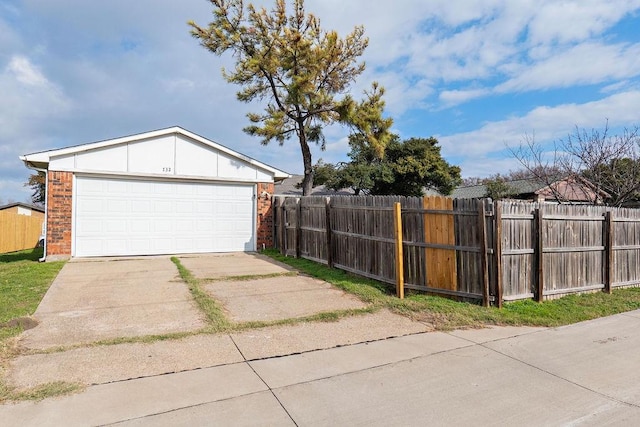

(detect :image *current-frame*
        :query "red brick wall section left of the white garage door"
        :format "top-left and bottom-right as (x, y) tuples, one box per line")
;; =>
(47, 171), (73, 258)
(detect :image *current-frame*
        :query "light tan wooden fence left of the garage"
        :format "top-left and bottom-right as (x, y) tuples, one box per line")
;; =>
(0, 211), (43, 253)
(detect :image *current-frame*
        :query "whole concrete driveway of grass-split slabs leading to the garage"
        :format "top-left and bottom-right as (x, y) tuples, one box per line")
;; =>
(6, 254), (430, 389)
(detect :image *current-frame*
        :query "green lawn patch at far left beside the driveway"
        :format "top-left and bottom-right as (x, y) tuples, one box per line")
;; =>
(0, 248), (64, 340)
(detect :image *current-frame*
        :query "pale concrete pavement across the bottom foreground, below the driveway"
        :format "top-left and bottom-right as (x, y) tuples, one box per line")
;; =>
(5, 311), (640, 426)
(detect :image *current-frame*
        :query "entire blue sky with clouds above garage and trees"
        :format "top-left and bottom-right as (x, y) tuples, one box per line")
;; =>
(0, 0), (640, 203)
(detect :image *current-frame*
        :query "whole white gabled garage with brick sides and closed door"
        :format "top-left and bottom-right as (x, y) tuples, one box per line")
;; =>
(21, 127), (289, 258)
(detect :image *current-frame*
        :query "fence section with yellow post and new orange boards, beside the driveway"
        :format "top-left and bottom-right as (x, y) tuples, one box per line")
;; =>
(274, 196), (495, 304)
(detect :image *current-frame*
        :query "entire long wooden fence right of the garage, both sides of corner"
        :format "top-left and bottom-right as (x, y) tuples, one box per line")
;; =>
(274, 196), (640, 306)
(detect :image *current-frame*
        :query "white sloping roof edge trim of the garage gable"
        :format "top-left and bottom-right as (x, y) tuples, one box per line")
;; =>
(20, 126), (290, 180)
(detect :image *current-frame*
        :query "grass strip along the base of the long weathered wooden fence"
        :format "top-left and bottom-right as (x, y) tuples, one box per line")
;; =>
(264, 250), (640, 330)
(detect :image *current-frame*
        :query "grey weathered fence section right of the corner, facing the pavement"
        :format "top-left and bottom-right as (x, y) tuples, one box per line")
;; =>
(496, 202), (640, 301)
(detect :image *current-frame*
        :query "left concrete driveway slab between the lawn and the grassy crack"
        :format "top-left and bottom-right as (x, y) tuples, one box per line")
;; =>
(21, 257), (205, 349)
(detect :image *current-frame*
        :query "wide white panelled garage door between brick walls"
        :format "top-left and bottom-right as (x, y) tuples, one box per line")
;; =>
(74, 177), (255, 257)
